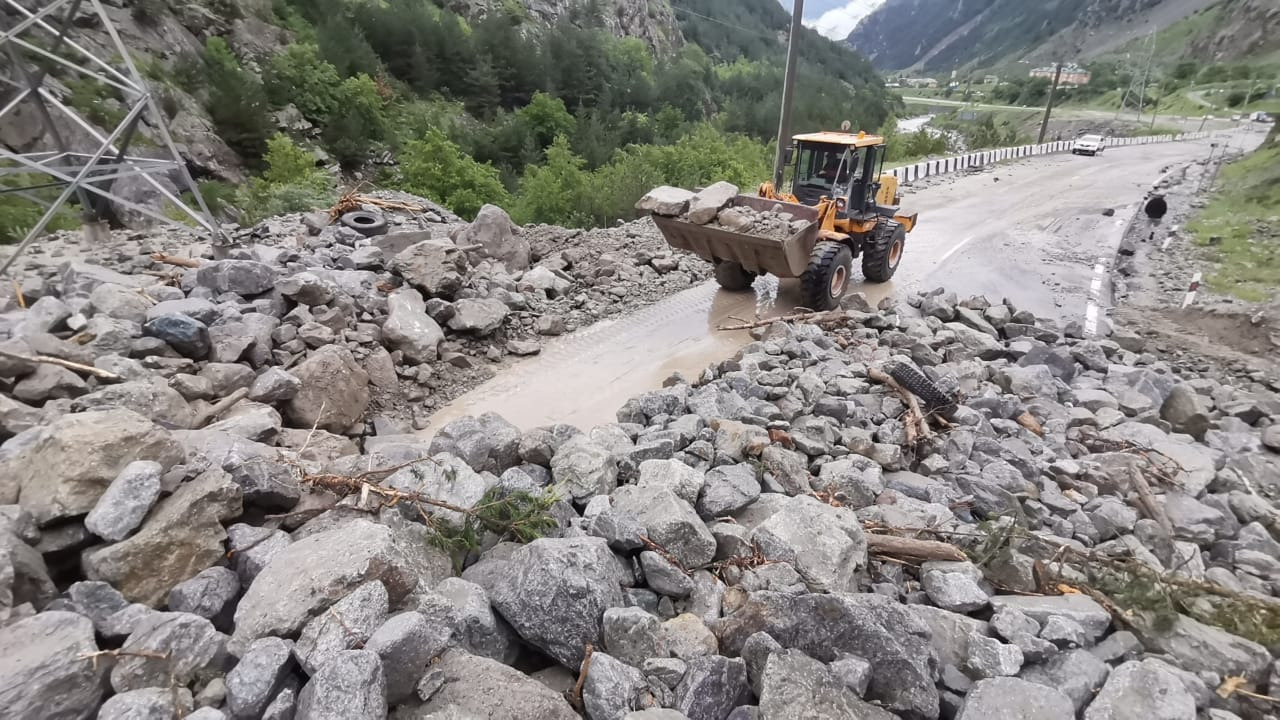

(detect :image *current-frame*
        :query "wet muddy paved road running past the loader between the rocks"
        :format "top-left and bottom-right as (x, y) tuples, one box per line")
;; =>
(425, 131), (1256, 433)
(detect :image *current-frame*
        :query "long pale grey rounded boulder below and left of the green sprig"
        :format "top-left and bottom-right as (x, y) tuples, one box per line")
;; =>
(229, 519), (453, 652)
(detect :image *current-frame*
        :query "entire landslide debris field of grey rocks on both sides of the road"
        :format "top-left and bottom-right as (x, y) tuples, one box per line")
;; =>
(0, 180), (1280, 720)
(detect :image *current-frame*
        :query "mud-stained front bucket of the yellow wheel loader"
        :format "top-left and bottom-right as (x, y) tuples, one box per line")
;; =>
(653, 195), (818, 278)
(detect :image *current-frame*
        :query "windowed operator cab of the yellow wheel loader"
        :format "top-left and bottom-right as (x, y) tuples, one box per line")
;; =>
(791, 132), (884, 217)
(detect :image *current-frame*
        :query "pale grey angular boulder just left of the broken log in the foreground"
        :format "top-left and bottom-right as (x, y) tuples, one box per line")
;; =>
(751, 495), (867, 592)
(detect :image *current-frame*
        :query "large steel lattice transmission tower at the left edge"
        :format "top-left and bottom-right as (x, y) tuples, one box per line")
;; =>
(0, 0), (221, 275)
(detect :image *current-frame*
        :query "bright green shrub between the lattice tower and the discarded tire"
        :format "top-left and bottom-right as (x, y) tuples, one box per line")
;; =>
(237, 135), (334, 224)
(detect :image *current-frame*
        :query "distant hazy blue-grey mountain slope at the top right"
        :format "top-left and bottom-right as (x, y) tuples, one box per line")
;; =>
(847, 0), (1223, 73)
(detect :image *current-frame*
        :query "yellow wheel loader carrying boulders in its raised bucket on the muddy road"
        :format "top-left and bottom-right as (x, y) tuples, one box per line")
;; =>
(653, 132), (915, 310)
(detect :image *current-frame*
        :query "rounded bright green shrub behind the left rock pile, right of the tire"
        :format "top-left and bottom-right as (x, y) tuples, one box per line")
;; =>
(396, 129), (511, 219)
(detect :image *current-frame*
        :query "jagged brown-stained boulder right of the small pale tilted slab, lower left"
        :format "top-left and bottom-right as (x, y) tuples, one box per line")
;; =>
(83, 469), (242, 607)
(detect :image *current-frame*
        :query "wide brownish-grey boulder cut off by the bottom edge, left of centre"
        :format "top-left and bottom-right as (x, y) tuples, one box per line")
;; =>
(407, 650), (580, 720)
